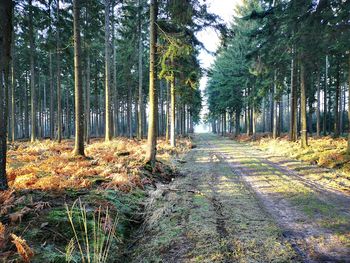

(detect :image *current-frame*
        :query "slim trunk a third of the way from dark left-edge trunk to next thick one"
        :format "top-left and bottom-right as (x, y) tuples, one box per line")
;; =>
(28, 0), (36, 142)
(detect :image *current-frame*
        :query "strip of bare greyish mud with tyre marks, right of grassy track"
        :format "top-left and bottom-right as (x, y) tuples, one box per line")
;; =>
(208, 138), (350, 263)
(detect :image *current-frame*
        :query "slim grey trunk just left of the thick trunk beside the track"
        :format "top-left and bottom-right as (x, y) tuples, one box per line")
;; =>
(137, 0), (143, 139)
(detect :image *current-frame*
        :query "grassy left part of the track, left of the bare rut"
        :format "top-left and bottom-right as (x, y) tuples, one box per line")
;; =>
(132, 135), (298, 262)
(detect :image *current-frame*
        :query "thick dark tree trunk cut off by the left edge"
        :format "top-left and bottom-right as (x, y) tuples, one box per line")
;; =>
(0, 0), (13, 191)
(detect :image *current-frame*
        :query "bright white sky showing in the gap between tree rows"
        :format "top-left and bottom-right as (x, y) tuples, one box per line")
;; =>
(195, 0), (242, 132)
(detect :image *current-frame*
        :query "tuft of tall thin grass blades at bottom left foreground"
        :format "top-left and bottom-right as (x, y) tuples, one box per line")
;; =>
(66, 198), (118, 263)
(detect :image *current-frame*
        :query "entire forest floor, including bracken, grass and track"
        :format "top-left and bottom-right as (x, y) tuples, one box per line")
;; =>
(0, 134), (350, 262)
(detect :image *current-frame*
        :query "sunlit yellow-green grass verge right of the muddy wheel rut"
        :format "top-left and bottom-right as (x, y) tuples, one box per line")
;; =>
(227, 137), (350, 252)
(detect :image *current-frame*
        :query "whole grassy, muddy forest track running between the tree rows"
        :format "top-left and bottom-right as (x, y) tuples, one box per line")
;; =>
(133, 134), (350, 262)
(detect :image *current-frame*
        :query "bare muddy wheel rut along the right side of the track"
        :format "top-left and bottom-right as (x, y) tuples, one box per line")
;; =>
(209, 138), (350, 262)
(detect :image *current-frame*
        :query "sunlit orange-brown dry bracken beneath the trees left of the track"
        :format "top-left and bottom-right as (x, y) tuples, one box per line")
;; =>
(7, 138), (191, 191)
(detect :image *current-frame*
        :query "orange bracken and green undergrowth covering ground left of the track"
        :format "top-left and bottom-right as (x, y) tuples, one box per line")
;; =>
(0, 139), (191, 263)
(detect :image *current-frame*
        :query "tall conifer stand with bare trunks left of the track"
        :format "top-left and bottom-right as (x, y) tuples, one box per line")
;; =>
(0, 0), (221, 189)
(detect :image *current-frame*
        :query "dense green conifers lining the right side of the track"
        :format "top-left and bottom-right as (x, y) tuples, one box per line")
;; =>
(206, 0), (350, 150)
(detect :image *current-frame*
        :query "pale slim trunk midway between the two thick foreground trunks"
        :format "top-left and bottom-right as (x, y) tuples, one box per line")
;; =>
(105, 0), (113, 141)
